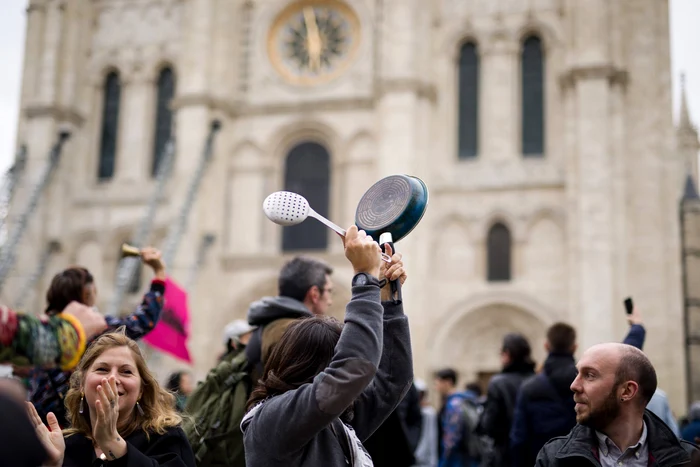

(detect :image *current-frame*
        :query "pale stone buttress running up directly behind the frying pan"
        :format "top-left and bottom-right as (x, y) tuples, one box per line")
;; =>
(373, 0), (434, 377)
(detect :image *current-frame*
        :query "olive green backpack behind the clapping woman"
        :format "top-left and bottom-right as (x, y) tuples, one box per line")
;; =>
(182, 351), (252, 467)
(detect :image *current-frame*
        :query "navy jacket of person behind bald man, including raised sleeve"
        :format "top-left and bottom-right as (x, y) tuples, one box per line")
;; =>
(510, 324), (646, 467)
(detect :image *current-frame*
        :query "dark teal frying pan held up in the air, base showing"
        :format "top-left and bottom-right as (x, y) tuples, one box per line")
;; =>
(355, 175), (428, 301)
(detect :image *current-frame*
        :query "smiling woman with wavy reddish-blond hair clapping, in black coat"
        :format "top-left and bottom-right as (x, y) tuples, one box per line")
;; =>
(27, 331), (195, 467)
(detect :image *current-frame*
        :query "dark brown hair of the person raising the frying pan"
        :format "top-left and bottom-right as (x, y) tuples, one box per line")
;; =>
(246, 316), (343, 410)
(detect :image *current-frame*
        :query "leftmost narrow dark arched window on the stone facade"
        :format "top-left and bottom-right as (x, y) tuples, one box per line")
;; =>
(97, 71), (121, 180)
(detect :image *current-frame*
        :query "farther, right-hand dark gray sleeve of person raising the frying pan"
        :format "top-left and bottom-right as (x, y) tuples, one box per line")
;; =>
(351, 302), (413, 442)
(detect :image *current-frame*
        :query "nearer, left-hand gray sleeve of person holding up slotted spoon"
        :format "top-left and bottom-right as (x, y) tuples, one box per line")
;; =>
(244, 285), (383, 459)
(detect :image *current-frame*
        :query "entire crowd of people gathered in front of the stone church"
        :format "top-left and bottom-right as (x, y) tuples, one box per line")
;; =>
(0, 226), (700, 467)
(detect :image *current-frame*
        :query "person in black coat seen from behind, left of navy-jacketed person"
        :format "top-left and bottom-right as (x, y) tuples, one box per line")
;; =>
(477, 333), (535, 467)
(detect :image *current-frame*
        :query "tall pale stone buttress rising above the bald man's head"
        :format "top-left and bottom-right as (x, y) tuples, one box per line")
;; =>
(563, 0), (621, 349)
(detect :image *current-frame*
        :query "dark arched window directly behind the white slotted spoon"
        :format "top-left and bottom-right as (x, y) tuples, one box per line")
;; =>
(282, 142), (330, 251)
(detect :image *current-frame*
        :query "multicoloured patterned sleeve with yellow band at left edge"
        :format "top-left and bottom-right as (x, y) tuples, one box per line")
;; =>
(0, 305), (86, 370)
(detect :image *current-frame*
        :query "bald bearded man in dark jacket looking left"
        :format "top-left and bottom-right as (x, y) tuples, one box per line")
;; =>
(536, 344), (697, 467)
